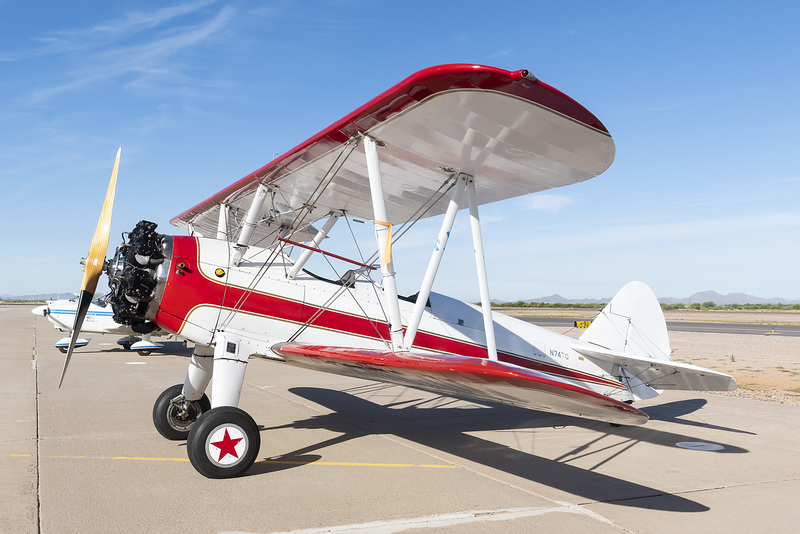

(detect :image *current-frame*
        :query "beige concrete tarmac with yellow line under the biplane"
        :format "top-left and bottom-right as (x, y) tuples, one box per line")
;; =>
(0, 307), (800, 534)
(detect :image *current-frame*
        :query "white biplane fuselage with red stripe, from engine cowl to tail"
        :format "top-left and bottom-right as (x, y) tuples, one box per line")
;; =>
(106, 232), (630, 400)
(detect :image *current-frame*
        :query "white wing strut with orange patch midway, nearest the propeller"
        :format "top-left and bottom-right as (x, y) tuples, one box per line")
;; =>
(364, 135), (403, 351)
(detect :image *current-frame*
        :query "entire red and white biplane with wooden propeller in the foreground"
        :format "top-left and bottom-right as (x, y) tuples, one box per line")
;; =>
(61, 64), (736, 478)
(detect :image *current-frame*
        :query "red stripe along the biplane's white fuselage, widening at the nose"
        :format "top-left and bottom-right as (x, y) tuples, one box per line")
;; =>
(155, 236), (621, 388)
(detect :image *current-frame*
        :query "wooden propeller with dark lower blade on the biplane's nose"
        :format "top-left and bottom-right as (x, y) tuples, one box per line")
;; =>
(58, 148), (122, 388)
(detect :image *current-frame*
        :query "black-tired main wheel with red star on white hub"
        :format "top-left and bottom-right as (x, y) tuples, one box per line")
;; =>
(186, 406), (261, 478)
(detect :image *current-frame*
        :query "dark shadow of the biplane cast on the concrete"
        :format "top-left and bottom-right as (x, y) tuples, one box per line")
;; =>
(249, 384), (748, 512)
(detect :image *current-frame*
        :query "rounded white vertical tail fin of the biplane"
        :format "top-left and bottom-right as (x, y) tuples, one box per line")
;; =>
(580, 282), (672, 361)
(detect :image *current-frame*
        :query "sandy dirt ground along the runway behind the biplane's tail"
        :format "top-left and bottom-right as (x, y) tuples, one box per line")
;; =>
(496, 308), (800, 405)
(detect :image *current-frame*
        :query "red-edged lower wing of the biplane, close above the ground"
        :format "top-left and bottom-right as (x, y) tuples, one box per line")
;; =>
(272, 343), (648, 424)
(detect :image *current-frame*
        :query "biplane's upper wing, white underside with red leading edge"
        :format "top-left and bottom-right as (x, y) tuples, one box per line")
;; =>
(171, 64), (614, 246)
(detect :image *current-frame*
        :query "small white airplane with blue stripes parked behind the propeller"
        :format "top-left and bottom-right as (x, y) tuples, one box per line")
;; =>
(31, 295), (164, 356)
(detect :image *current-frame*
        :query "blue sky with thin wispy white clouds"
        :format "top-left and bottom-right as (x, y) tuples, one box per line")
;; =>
(0, 0), (800, 301)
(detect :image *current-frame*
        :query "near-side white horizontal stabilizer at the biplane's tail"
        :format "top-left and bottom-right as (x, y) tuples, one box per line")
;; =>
(571, 343), (736, 391)
